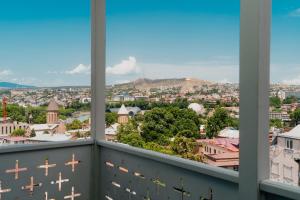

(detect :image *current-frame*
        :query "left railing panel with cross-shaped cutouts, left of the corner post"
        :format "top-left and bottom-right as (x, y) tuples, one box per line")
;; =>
(0, 140), (94, 200)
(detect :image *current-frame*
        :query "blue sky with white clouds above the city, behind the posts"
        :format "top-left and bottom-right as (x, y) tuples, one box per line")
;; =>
(0, 0), (300, 86)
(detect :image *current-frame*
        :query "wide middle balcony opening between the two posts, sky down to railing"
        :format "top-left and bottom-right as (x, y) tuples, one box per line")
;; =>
(105, 0), (240, 170)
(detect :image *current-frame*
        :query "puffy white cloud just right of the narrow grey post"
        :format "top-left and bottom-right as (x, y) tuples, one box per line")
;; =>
(106, 56), (139, 75)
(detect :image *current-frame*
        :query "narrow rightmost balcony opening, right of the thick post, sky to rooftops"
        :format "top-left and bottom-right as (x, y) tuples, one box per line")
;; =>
(269, 0), (300, 186)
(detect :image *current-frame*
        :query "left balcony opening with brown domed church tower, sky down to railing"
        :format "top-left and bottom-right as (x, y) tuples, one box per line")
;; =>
(0, 0), (91, 147)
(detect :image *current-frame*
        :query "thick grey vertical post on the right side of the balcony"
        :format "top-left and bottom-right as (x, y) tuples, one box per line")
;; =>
(239, 0), (271, 200)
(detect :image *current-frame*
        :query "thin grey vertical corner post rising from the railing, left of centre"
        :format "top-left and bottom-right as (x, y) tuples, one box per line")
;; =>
(91, 0), (106, 140)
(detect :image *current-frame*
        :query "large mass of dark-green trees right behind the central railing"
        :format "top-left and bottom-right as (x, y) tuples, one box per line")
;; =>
(117, 107), (200, 160)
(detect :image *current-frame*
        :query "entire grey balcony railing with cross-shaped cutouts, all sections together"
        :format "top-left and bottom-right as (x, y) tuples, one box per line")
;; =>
(0, 140), (300, 200)
